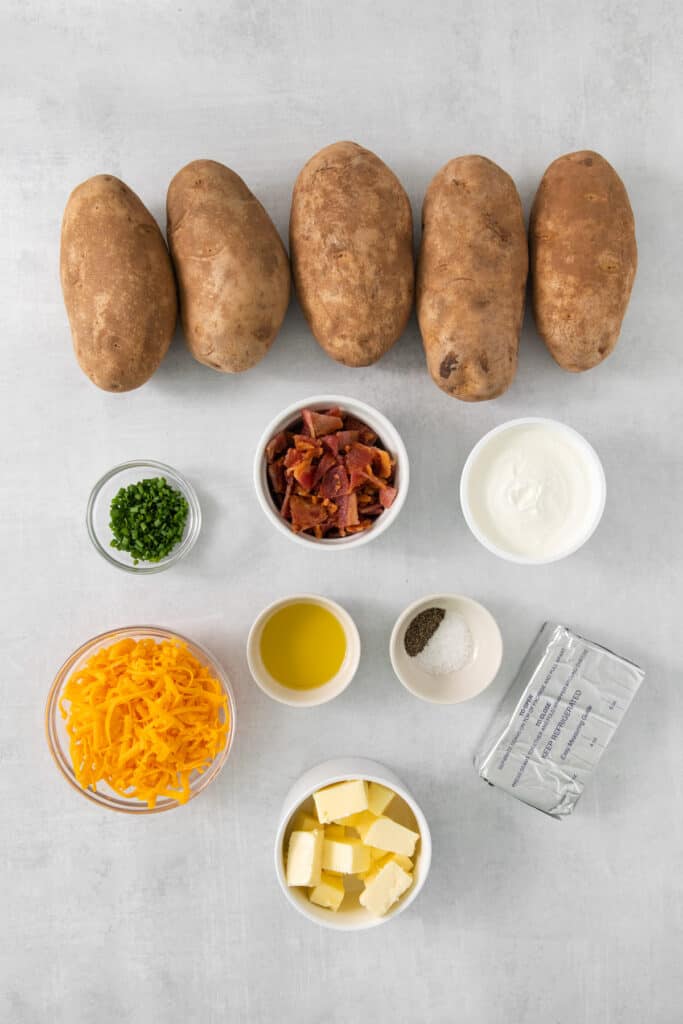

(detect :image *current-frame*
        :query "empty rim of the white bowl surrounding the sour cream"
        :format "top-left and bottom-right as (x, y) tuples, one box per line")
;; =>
(460, 416), (606, 565)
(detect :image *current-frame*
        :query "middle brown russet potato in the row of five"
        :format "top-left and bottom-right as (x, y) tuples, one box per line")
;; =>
(290, 142), (415, 367)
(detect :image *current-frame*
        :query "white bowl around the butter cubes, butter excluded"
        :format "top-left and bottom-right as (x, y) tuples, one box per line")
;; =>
(274, 758), (432, 932)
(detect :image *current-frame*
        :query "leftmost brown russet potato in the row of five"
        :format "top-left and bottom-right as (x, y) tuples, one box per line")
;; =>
(59, 174), (177, 391)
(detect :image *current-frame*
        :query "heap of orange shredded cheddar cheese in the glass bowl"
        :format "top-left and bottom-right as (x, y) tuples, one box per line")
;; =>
(59, 638), (230, 807)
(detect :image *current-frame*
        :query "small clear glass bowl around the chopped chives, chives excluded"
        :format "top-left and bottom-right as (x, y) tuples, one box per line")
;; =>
(85, 459), (202, 575)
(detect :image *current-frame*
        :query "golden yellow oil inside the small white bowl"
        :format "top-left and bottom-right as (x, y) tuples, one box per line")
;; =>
(260, 601), (346, 690)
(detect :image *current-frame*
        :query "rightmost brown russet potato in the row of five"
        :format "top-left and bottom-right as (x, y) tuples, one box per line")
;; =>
(529, 150), (638, 373)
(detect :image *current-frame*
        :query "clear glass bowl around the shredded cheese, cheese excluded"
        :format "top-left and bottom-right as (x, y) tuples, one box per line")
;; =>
(45, 626), (236, 814)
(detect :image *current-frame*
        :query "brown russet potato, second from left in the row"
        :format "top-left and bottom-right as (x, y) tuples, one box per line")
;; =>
(166, 160), (291, 374)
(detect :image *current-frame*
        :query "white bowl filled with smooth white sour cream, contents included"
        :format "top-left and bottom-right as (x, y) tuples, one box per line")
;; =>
(460, 419), (605, 562)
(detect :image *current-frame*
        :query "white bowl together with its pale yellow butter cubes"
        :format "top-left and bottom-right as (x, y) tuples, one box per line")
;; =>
(274, 758), (431, 931)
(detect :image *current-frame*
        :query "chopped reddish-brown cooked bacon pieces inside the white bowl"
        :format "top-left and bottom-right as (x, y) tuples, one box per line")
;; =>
(265, 409), (396, 539)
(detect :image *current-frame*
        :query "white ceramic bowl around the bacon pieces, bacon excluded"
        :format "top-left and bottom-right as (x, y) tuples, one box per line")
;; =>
(254, 394), (410, 551)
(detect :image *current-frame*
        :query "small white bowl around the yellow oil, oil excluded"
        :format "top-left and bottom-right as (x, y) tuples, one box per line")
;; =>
(247, 594), (360, 708)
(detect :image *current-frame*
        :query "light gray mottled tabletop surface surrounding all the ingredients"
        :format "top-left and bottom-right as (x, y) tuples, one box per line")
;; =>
(0, 0), (683, 1024)
